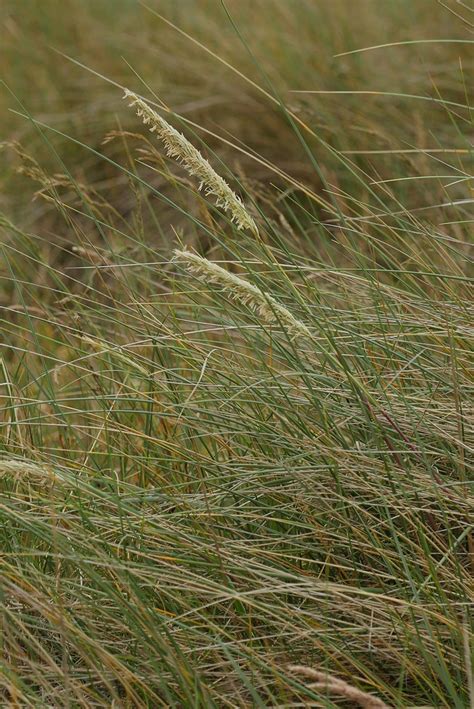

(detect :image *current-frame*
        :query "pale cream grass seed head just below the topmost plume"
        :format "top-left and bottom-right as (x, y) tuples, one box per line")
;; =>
(174, 249), (311, 337)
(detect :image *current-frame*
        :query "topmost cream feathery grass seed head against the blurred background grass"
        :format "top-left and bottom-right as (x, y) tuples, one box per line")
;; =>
(124, 90), (258, 234)
